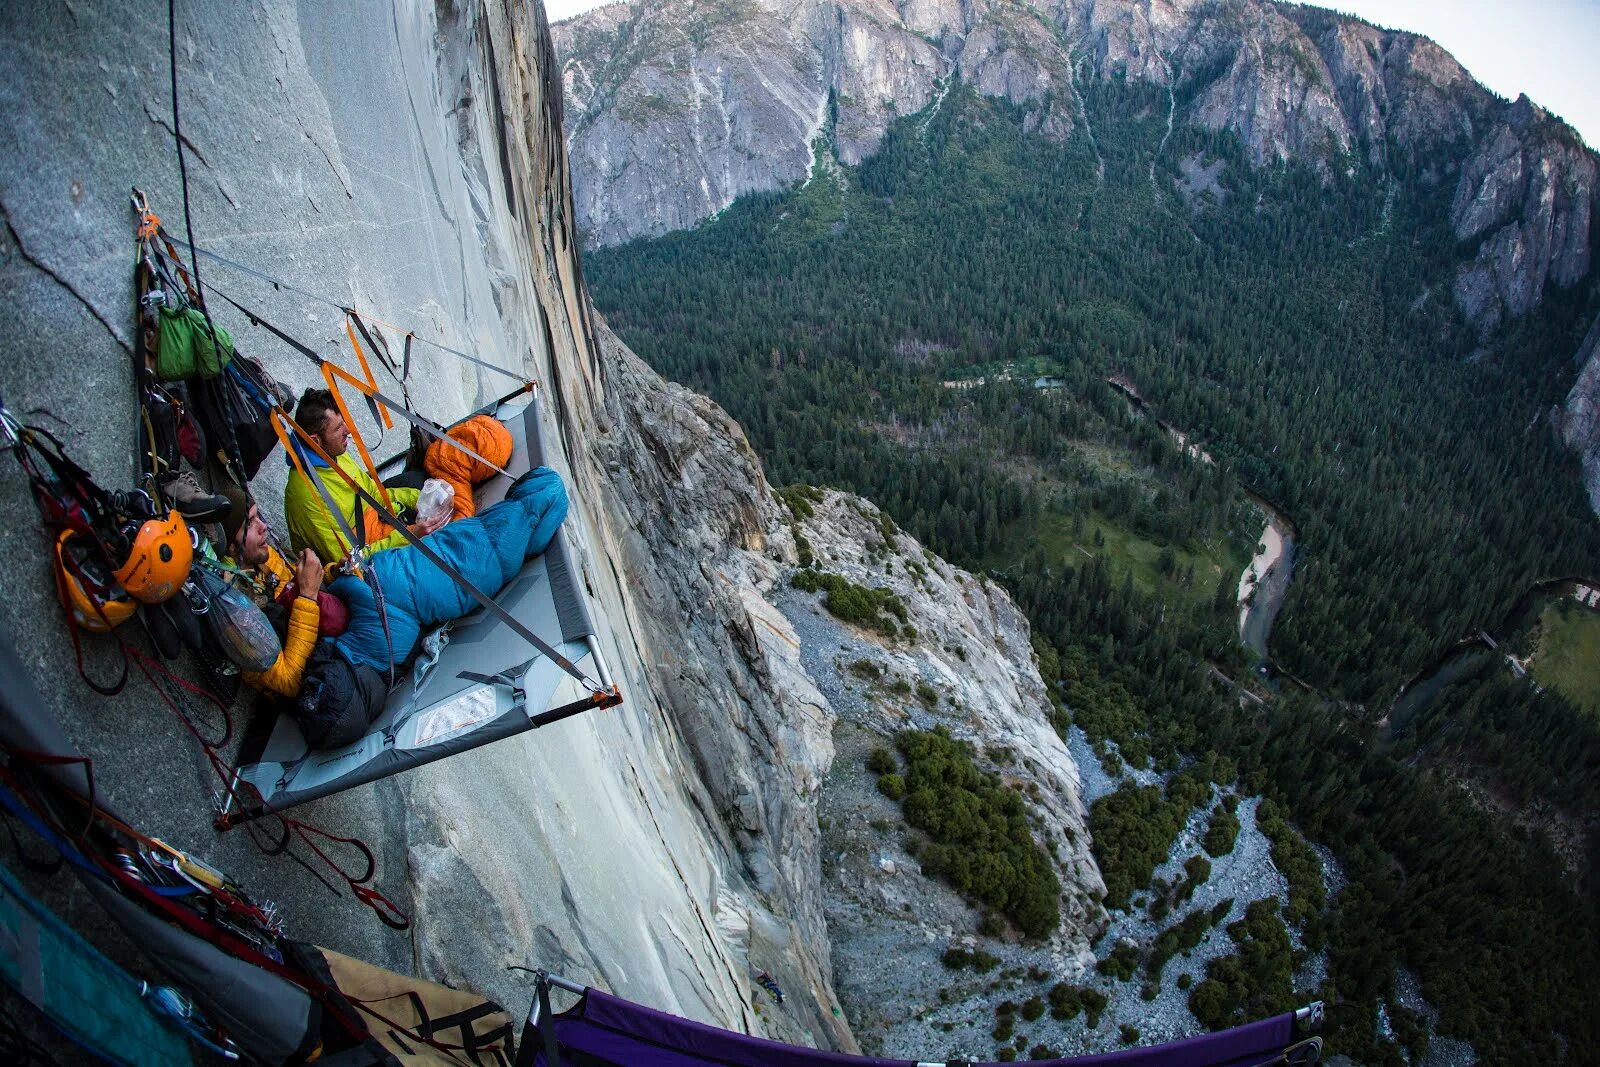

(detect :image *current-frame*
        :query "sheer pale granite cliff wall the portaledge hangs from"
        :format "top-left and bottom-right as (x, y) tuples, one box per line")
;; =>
(0, 0), (1098, 1049)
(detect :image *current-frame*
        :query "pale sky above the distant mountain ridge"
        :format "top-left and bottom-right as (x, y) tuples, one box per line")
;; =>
(544, 0), (1600, 147)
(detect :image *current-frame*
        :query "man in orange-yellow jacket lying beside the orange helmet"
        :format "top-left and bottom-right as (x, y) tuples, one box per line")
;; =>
(222, 486), (322, 699)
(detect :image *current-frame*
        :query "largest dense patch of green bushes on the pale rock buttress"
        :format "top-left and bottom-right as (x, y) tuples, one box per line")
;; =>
(894, 726), (1061, 937)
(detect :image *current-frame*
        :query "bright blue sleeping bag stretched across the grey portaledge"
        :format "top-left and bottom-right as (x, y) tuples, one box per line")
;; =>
(328, 467), (566, 675)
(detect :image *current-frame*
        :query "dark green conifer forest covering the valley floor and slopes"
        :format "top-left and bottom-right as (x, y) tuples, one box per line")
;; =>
(587, 83), (1600, 1064)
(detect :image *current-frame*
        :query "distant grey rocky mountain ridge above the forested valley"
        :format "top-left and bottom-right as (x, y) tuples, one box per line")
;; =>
(554, 0), (1597, 331)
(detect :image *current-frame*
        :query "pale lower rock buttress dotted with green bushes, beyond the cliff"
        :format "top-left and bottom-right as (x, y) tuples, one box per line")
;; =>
(770, 491), (1107, 1057)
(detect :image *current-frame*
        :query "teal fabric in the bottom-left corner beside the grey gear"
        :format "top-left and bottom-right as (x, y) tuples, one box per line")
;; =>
(0, 867), (194, 1067)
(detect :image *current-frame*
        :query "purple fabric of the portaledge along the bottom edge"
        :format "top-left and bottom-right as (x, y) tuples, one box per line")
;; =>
(533, 989), (1315, 1067)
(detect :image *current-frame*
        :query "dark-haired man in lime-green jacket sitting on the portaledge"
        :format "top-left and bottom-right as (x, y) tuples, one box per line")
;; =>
(283, 389), (448, 563)
